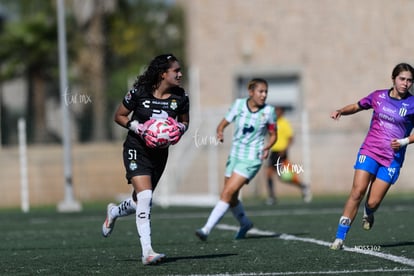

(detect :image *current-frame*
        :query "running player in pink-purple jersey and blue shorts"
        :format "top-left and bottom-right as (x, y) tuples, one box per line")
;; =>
(331, 63), (414, 250)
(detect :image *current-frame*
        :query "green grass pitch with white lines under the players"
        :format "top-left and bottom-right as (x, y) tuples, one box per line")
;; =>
(0, 195), (414, 276)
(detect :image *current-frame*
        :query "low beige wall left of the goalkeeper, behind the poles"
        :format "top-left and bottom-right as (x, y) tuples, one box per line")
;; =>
(0, 143), (132, 208)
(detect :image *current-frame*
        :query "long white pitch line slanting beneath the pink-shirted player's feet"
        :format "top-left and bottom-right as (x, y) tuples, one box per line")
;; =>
(217, 224), (414, 267)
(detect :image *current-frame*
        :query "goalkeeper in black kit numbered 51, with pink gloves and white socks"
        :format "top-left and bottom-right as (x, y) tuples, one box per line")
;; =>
(102, 54), (190, 265)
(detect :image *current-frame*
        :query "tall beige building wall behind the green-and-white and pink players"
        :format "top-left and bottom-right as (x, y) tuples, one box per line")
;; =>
(177, 0), (414, 198)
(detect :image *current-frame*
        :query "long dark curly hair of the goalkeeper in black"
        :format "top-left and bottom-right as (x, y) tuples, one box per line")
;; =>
(134, 54), (178, 91)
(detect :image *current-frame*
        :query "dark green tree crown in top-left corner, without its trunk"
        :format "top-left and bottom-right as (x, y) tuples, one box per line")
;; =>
(0, 0), (57, 80)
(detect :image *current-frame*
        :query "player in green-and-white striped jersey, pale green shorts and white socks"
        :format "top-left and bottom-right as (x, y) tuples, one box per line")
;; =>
(196, 79), (277, 241)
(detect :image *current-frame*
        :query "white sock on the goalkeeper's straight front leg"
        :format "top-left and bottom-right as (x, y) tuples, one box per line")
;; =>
(136, 190), (153, 256)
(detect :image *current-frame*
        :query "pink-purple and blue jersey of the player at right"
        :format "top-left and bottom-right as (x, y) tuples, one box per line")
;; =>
(358, 89), (414, 167)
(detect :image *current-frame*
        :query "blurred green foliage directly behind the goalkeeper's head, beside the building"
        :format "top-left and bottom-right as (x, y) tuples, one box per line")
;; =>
(106, 0), (185, 101)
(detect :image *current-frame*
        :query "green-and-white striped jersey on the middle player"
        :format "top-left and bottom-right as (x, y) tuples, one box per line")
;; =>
(224, 98), (276, 160)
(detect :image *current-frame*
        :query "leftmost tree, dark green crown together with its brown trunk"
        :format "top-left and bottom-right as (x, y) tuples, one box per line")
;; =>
(0, 1), (57, 142)
